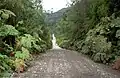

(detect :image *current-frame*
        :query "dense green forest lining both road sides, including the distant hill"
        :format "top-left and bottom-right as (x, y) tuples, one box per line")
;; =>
(0, 0), (120, 77)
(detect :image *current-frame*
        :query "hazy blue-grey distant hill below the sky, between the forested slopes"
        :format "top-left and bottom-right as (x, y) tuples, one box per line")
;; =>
(45, 7), (69, 33)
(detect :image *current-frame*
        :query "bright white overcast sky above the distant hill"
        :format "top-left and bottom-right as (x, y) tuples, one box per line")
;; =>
(42, 0), (70, 12)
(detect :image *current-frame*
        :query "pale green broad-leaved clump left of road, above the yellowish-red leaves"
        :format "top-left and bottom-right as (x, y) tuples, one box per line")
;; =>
(20, 34), (47, 52)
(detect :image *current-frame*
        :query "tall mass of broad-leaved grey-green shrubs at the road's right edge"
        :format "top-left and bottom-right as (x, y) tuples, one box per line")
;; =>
(79, 17), (119, 63)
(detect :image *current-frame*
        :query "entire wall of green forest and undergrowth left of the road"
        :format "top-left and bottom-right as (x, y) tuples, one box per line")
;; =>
(0, 0), (51, 77)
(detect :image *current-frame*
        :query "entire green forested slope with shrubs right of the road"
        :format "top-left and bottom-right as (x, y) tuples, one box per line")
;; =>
(56, 0), (120, 64)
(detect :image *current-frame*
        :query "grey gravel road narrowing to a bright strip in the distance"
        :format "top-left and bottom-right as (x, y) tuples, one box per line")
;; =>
(13, 35), (120, 78)
